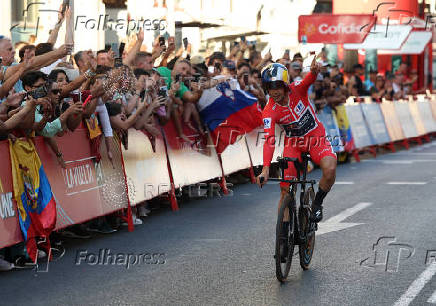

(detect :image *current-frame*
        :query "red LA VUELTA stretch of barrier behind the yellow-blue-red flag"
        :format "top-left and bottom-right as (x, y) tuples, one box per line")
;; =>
(0, 129), (128, 248)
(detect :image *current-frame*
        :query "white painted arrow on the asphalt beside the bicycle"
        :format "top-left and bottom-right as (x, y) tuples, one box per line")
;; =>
(316, 202), (372, 236)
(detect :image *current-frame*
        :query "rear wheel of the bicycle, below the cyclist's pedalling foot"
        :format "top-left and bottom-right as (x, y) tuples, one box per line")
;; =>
(298, 187), (316, 270)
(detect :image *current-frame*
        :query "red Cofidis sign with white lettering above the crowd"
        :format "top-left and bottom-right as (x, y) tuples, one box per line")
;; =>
(298, 14), (376, 44)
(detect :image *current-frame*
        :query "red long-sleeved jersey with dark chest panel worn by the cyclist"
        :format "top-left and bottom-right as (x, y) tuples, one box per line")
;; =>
(262, 72), (325, 166)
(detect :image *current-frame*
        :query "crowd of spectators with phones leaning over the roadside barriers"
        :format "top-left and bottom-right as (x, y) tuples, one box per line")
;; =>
(0, 5), (426, 268)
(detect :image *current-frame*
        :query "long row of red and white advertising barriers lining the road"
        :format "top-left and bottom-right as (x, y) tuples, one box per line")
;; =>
(0, 96), (436, 248)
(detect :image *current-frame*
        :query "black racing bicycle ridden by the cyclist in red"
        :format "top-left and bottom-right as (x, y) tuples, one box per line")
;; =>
(258, 153), (318, 283)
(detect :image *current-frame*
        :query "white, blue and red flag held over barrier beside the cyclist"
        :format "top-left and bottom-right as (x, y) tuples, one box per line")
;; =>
(198, 80), (263, 154)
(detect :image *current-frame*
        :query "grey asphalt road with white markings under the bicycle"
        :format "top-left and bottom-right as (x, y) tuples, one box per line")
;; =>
(0, 142), (436, 305)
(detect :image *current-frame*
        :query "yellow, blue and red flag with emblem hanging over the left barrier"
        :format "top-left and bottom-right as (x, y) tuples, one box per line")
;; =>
(9, 139), (56, 262)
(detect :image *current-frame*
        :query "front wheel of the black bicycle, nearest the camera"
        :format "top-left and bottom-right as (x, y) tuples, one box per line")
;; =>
(275, 195), (295, 282)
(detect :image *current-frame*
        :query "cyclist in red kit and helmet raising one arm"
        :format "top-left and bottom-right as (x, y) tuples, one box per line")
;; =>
(257, 58), (336, 222)
